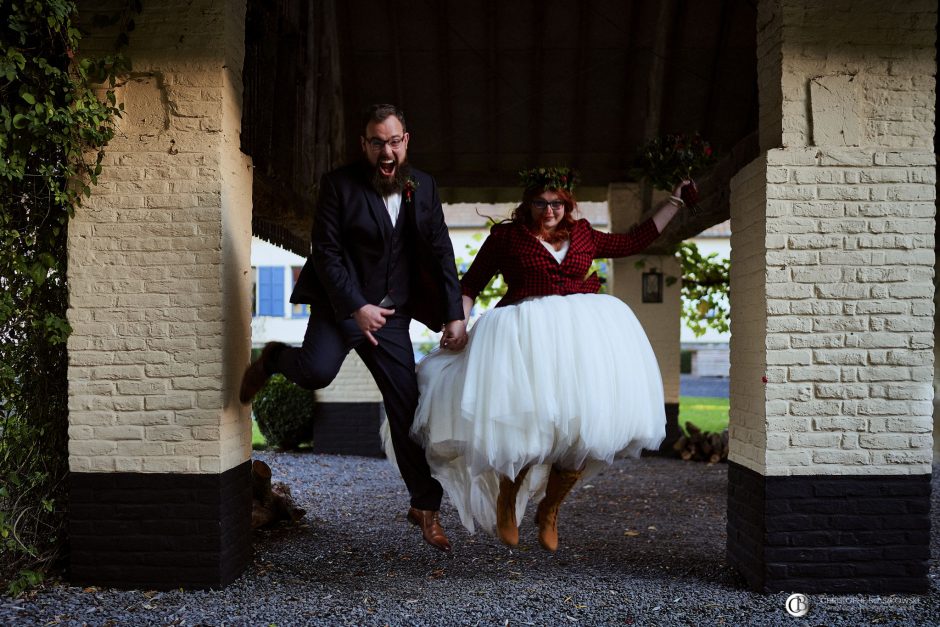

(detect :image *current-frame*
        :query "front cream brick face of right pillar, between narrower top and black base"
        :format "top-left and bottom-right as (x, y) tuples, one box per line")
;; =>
(766, 149), (935, 474)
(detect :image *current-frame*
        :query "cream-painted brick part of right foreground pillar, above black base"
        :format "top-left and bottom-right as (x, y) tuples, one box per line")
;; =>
(730, 0), (937, 475)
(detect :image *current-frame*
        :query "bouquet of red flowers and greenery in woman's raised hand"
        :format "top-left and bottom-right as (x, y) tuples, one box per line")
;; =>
(635, 133), (715, 212)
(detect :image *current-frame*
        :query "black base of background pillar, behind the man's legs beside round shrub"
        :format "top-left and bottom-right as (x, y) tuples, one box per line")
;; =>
(313, 403), (385, 457)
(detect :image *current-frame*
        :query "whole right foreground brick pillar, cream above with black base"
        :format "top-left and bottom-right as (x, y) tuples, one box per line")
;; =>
(728, 0), (937, 592)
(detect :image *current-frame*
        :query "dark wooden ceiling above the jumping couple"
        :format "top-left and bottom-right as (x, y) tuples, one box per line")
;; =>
(243, 0), (758, 255)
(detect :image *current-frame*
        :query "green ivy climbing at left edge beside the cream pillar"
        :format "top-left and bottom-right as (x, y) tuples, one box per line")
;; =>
(0, 0), (127, 594)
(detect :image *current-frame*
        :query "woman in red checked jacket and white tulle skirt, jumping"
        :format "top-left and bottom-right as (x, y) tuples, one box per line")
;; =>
(386, 168), (689, 551)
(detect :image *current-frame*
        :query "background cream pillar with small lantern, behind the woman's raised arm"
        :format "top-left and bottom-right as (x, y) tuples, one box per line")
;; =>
(607, 183), (682, 451)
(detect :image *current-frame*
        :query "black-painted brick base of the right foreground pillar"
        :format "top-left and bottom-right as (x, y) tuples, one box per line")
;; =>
(728, 462), (930, 593)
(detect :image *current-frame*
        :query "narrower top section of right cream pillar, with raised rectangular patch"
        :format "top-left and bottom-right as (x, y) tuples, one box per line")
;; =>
(758, 0), (937, 149)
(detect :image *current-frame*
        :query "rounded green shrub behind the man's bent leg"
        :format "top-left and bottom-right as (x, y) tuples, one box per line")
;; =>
(253, 374), (317, 450)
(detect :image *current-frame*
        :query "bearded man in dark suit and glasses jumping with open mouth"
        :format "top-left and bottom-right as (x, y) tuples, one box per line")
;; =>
(239, 104), (467, 551)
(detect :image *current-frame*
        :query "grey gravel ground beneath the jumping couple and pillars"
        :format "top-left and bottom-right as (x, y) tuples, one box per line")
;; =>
(0, 452), (940, 627)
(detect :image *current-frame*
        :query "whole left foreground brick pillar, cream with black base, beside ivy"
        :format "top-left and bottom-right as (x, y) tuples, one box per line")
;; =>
(68, 0), (251, 588)
